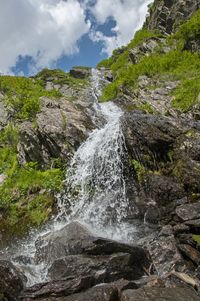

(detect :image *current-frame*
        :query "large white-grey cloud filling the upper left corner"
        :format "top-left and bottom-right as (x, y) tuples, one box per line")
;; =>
(0, 0), (90, 73)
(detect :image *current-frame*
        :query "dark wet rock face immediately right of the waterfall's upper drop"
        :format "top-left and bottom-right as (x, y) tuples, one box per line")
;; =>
(123, 111), (180, 167)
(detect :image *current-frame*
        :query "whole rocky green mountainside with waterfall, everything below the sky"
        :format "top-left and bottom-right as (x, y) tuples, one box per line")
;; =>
(0, 0), (200, 301)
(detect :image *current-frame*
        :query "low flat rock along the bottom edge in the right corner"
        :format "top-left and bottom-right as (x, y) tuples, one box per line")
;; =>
(121, 287), (200, 301)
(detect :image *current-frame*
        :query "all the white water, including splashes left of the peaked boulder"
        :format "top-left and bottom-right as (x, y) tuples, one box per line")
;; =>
(1, 70), (138, 285)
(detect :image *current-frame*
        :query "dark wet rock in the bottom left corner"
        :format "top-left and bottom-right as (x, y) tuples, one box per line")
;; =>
(0, 261), (25, 301)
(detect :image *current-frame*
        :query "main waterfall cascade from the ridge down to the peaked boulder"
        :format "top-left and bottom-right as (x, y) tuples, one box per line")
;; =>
(56, 70), (127, 236)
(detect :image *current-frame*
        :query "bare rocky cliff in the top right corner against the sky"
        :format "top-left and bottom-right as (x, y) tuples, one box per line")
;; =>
(145, 0), (200, 34)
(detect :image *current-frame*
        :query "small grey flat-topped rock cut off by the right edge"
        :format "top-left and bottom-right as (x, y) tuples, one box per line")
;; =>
(176, 202), (200, 221)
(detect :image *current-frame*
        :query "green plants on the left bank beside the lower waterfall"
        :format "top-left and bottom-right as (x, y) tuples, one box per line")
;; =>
(0, 124), (64, 233)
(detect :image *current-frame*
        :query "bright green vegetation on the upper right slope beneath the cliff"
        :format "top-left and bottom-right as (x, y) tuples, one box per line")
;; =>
(99, 11), (200, 111)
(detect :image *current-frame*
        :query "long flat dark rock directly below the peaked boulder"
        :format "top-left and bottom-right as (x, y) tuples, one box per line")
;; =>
(48, 253), (144, 284)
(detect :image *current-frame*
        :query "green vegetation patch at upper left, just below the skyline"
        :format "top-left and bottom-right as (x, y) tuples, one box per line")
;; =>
(0, 76), (61, 119)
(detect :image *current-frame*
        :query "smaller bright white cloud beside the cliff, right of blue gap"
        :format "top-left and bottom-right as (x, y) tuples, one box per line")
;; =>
(91, 0), (152, 55)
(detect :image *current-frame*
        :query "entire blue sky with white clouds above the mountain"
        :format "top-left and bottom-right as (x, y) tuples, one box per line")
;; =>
(0, 0), (152, 75)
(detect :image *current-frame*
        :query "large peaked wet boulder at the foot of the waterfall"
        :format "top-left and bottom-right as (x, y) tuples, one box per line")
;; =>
(35, 222), (149, 269)
